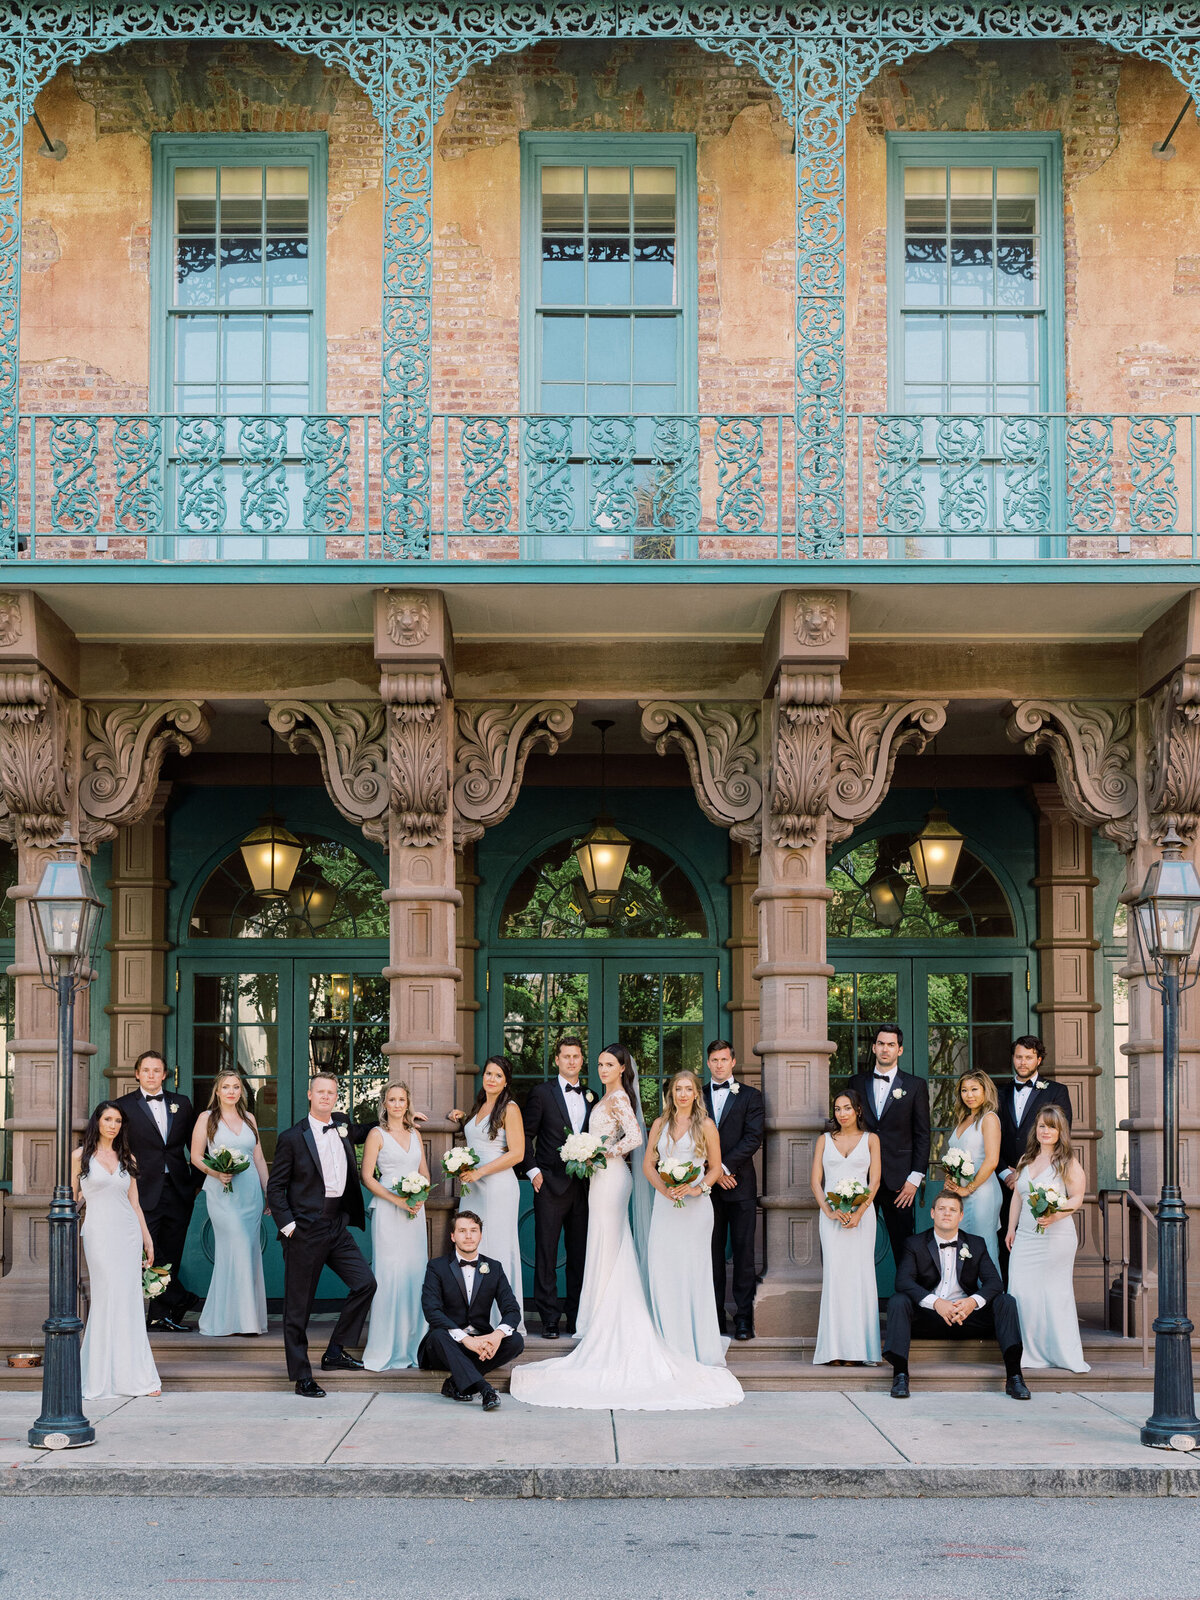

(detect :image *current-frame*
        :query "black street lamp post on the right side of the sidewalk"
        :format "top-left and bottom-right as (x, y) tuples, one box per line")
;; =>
(1133, 829), (1200, 1450)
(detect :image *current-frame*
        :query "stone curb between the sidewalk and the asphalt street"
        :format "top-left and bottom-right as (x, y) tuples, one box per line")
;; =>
(0, 1464), (1200, 1499)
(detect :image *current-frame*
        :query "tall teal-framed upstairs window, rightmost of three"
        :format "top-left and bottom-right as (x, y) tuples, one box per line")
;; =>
(880, 134), (1064, 557)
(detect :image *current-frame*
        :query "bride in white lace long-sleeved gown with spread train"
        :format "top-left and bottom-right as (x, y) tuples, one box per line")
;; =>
(512, 1045), (742, 1411)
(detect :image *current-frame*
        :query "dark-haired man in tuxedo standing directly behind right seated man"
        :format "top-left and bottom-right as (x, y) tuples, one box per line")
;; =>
(848, 1022), (930, 1267)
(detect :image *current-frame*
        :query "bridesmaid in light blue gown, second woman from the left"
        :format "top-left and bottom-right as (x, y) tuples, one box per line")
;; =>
(192, 1072), (267, 1338)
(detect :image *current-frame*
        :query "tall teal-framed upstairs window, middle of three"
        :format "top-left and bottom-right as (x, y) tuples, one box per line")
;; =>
(522, 134), (696, 558)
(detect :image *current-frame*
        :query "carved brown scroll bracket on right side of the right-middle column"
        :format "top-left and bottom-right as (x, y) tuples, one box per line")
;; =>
(826, 699), (946, 845)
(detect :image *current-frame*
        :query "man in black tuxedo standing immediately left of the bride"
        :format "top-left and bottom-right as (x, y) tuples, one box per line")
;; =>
(523, 1035), (595, 1339)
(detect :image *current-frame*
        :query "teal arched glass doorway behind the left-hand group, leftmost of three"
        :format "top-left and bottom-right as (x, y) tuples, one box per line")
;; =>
(174, 832), (389, 1298)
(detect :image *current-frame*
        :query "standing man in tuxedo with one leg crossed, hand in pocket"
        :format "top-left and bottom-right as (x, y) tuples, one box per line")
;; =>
(267, 1072), (374, 1400)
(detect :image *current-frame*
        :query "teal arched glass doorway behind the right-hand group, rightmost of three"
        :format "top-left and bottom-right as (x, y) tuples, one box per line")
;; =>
(827, 832), (1032, 1267)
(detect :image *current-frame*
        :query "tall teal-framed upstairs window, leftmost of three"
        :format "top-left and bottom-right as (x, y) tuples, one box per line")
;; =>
(155, 134), (325, 558)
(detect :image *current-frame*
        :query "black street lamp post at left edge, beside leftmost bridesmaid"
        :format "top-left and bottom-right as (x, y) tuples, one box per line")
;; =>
(29, 827), (104, 1450)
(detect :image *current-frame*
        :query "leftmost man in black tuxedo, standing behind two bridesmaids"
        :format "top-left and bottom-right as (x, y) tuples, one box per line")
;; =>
(117, 1050), (205, 1333)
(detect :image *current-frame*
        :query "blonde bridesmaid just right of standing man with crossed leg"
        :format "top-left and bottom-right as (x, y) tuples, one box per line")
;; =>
(362, 1083), (429, 1373)
